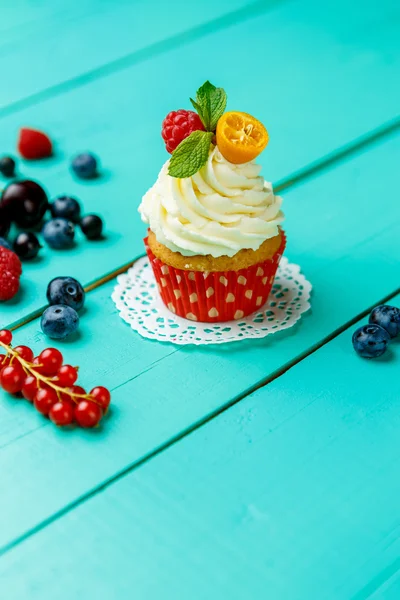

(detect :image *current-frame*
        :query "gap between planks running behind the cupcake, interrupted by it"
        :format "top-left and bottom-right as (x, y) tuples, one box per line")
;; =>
(8, 113), (400, 331)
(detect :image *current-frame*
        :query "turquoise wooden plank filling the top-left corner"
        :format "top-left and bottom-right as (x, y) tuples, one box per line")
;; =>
(0, 0), (264, 113)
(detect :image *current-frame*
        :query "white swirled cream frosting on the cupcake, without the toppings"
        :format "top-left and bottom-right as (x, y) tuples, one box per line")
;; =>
(139, 147), (283, 258)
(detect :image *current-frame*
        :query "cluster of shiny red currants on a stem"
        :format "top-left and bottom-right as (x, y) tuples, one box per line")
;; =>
(0, 329), (111, 427)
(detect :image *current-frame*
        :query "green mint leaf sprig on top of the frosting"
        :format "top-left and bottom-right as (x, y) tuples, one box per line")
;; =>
(168, 81), (227, 179)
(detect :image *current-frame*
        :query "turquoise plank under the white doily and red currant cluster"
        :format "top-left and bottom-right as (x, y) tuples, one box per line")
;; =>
(0, 137), (400, 546)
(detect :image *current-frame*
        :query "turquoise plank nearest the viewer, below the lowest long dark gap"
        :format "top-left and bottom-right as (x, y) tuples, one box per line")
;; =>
(0, 296), (400, 600)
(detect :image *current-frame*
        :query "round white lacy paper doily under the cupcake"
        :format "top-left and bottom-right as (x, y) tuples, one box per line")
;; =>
(112, 256), (312, 345)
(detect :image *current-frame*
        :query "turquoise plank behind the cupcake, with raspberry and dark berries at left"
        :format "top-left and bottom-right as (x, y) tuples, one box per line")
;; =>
(0, 0), (399, 325)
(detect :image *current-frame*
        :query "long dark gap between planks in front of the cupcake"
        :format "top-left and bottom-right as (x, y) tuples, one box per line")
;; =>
(0, 288), (400, 557)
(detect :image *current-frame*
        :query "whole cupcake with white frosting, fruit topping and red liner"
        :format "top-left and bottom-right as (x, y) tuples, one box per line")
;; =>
(139, 82), (286, 322)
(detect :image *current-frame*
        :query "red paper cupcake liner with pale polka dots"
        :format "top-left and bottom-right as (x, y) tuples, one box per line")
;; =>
(144, 231), (286, 323)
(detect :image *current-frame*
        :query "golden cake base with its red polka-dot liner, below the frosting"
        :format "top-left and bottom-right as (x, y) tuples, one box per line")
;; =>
(145, 230), (286, 323)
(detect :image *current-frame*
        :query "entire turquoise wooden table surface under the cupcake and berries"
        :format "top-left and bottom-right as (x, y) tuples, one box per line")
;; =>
(0, 0), (400, 600)
